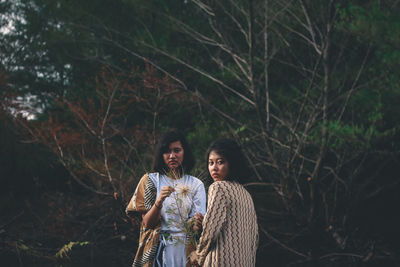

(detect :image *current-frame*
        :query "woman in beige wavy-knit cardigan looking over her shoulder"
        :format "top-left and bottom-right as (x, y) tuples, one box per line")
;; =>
(190, 139), (258, 267)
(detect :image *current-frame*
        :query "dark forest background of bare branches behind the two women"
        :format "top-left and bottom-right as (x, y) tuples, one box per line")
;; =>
(0, 0), (400, 266)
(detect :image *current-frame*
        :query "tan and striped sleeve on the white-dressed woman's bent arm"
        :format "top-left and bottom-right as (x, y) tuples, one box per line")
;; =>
(125, 174), (157, 215)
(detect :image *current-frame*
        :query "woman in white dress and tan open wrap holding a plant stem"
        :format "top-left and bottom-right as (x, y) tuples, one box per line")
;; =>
(126, 131), (206, 267)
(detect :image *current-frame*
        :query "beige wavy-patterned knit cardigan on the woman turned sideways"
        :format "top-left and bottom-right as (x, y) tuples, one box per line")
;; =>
(196, 181), (258, 267)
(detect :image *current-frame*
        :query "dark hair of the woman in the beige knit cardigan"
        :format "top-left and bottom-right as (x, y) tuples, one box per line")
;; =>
(206, 138), (251, 184)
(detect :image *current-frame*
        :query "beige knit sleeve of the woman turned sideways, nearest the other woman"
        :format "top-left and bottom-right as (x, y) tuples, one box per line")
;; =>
(196, 182), (227, 266)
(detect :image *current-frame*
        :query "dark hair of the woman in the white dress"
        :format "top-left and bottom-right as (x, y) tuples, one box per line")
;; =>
(152, 130), (194, 174)
